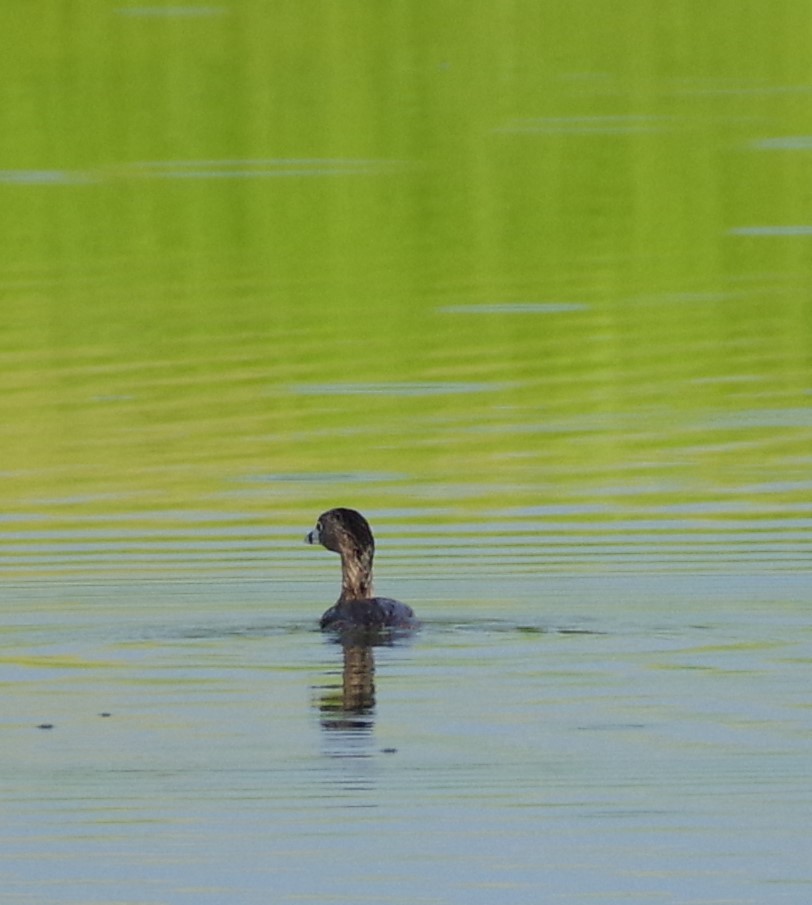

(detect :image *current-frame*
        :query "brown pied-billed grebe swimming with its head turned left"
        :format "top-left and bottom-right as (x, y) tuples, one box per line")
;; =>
(305, 509), (418, 631)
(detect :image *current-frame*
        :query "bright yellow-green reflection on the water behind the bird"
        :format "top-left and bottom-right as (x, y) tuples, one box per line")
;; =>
(0, 2), (812, 564)
